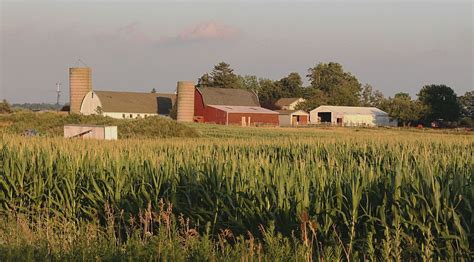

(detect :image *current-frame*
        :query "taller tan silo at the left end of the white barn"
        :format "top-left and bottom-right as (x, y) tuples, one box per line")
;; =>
(69, 67), (92, 114)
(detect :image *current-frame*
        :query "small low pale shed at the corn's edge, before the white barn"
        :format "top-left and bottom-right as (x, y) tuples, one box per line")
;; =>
(64, 125), (117, 140)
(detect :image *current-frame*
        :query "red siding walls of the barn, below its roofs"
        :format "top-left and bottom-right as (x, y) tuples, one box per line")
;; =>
(194, 89), (279, 126)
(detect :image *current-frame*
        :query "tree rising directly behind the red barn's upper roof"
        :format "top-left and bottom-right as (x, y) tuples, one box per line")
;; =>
(198, 62), (242, 88)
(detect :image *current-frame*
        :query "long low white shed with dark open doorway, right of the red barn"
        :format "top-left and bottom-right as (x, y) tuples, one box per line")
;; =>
(310, 106), (397, 126)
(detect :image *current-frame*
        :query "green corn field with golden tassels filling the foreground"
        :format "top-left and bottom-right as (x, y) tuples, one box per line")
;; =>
(0, 131), (474, 261)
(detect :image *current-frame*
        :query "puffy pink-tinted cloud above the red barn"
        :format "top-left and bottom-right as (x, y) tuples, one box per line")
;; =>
(160, 22), (241, 43)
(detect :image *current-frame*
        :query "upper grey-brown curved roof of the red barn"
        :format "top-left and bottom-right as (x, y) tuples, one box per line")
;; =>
(198, 87), (260, 107)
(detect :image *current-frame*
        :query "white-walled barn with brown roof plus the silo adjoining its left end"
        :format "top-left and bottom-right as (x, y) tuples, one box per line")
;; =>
(69, 68), (176, 118)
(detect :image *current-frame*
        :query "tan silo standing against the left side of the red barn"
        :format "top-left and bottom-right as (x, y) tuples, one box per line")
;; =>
(177, 81), (195, 122)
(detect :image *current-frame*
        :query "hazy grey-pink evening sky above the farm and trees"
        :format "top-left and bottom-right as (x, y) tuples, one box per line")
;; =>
(0, 0), (474, 103)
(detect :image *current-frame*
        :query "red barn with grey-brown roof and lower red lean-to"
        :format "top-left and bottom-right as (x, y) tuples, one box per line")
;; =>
(194, 87), (279, 126)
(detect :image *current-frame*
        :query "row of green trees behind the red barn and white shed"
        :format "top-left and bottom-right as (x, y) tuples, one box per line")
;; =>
(197, 62), (474, 127)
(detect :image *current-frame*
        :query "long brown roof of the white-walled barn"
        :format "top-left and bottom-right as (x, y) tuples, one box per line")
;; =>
(94, 91), (176, 115)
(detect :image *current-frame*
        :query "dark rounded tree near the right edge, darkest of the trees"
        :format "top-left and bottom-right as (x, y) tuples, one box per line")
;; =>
(418, 85), (461, 122)
